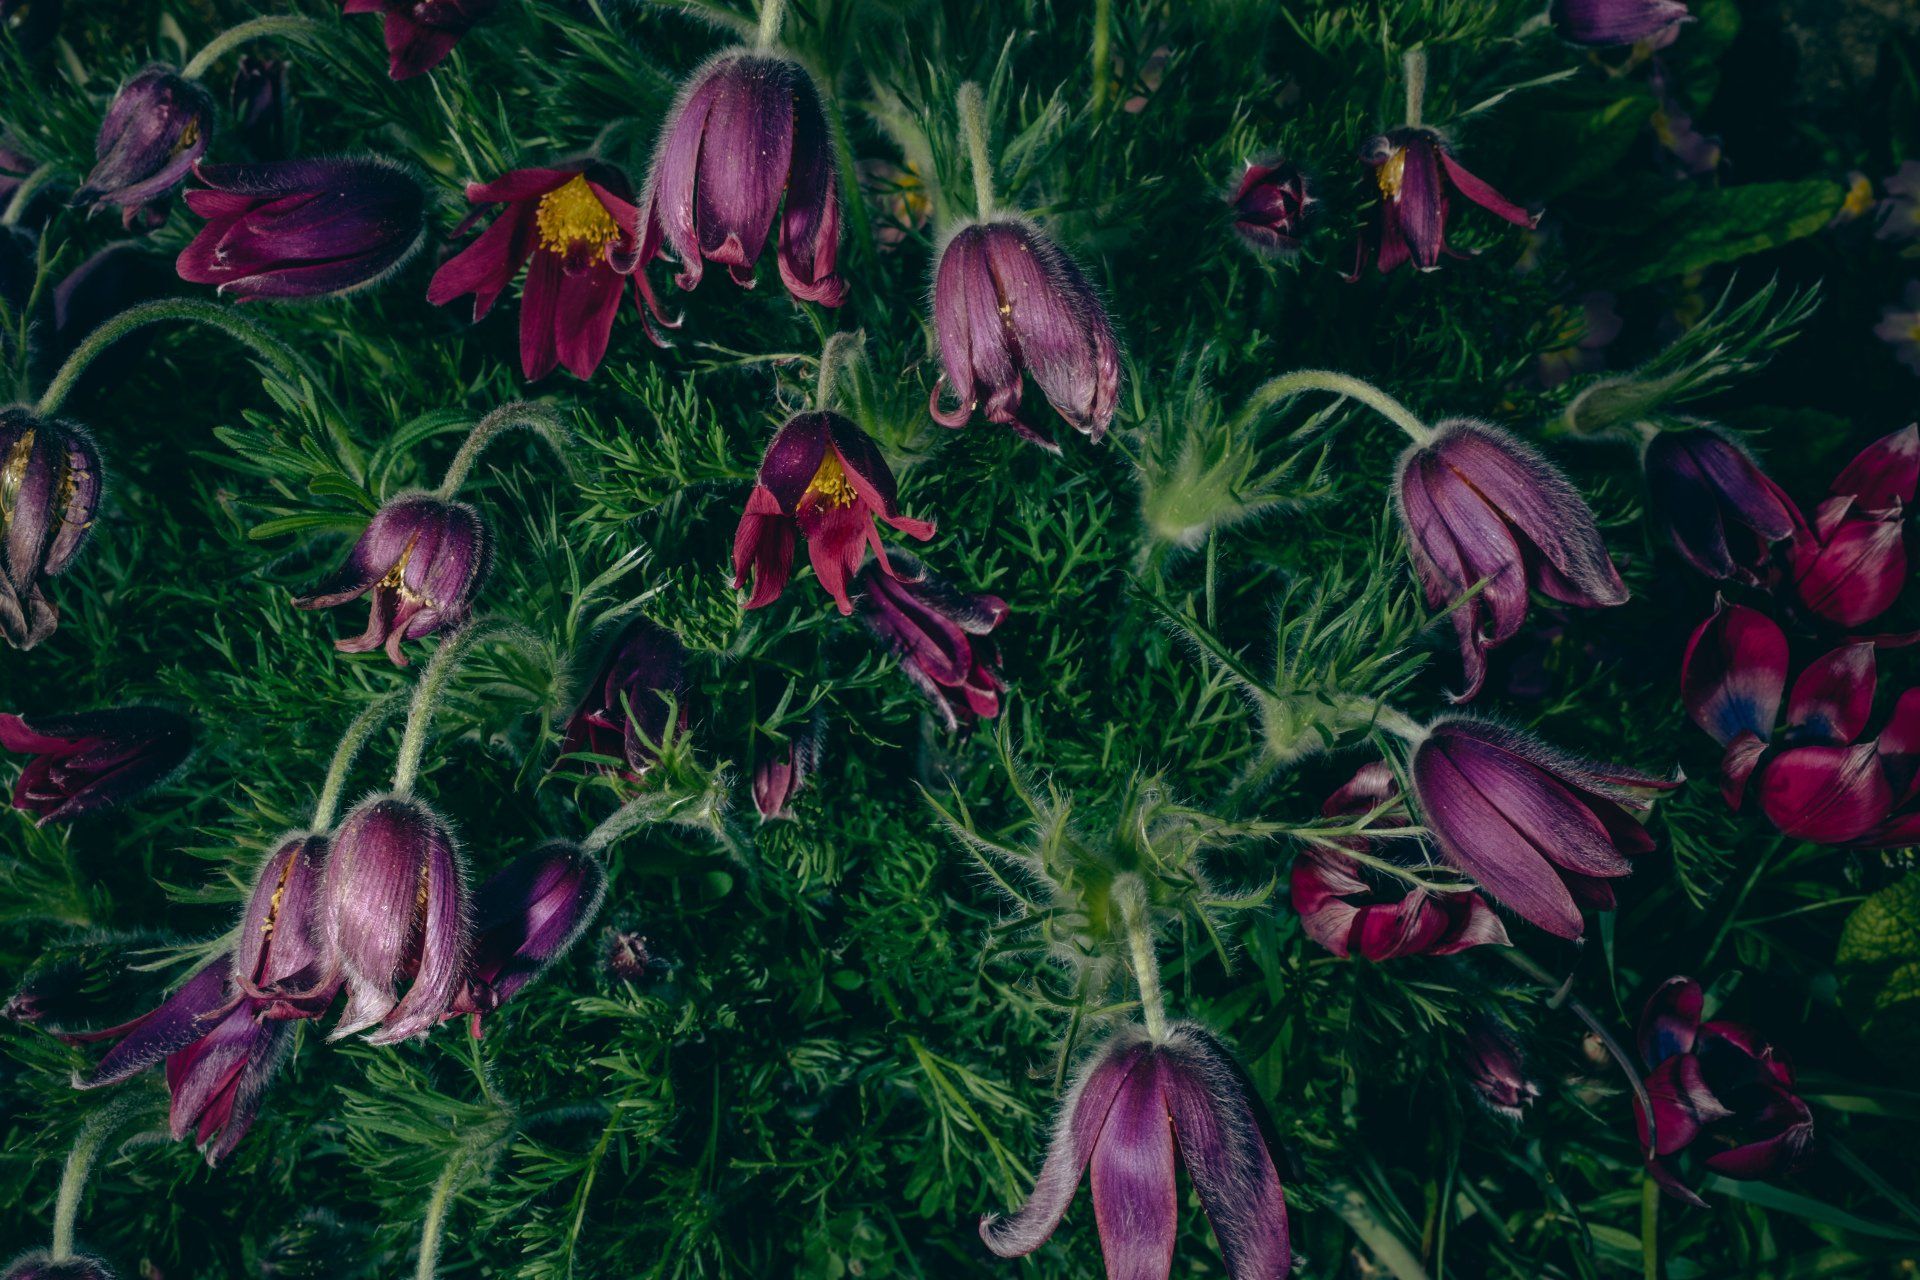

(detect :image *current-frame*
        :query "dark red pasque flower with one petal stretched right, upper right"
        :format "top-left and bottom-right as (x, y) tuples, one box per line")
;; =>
(1348, 127), (1540, 282)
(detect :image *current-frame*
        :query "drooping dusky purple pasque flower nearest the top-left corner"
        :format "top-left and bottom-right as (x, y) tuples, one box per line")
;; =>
(73, 63), (213, 230)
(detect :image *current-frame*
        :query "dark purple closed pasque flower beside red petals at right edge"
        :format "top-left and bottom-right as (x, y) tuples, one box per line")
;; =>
(1642, 426), (1799, 585)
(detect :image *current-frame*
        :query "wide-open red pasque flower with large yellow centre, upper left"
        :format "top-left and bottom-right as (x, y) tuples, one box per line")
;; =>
(426, 161), (639, 382)
